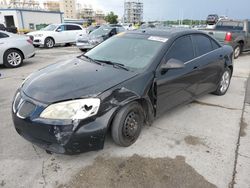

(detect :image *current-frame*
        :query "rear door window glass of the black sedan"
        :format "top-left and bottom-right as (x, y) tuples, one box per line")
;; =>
(193, 35), (213, 56)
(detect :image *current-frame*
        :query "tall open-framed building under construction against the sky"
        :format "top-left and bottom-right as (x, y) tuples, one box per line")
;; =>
(124, 0), (143, 24)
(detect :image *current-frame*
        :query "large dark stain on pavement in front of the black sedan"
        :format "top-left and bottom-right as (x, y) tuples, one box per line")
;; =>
(58, 155), (216, 188)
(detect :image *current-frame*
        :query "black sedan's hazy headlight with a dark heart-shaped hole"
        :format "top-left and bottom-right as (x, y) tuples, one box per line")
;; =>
(40, 98), (100, 120)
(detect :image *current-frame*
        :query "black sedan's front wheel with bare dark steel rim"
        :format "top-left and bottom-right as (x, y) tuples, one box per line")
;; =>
(111, 102), (144, 147)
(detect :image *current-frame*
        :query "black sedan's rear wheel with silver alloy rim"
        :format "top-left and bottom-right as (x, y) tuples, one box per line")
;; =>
(213, 68), (232, 96)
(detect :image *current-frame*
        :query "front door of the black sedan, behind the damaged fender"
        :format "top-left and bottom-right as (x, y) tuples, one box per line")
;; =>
(155, 36), (199, 116)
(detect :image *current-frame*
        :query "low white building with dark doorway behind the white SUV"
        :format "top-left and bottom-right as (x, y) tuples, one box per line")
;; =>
(0, 8), (63, 30)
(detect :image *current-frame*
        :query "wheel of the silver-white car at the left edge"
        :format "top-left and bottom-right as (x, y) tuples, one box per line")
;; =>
(3, 49), (24, 68)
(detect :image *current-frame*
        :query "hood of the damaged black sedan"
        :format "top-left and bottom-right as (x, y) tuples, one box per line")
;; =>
(21, 58), (137, 104)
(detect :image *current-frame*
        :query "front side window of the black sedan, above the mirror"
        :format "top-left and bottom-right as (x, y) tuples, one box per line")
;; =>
(166, 36), (194, 62)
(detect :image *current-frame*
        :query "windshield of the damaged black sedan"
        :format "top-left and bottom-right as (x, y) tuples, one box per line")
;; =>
(85, 36), (164, 69)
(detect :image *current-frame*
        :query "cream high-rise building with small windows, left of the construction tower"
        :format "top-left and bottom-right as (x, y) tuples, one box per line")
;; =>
(60, 0), (76, 19)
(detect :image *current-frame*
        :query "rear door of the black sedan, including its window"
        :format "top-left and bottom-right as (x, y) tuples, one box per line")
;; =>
(192, 34), (224, 96)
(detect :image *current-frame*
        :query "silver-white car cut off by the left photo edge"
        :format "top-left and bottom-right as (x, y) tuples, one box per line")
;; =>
(0, 31), (35, 68)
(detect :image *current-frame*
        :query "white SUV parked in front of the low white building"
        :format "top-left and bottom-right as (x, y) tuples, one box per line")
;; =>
(27, 23), (87, 48)
